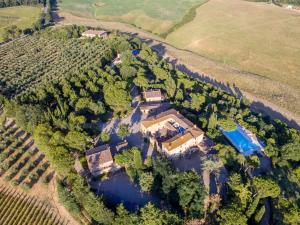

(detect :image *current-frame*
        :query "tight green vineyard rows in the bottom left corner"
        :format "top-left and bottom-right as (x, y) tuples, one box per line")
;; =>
(0, 186), (68, 225)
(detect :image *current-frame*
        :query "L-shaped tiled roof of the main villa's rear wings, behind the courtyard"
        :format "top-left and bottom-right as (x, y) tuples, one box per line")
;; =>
(142, 109), (194, 129)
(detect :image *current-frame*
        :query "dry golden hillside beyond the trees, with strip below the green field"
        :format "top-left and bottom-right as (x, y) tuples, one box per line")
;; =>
(58, 0), (300, 121)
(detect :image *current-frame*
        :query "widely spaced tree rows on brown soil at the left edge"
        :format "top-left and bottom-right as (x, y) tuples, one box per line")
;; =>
(0, 120), (53, 190)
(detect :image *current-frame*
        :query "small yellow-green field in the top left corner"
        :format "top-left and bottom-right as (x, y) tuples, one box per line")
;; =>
(0, 6), (41, 42)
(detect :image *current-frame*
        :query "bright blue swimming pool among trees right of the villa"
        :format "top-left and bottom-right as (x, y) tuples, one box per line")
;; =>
(222, 125), (263, 156)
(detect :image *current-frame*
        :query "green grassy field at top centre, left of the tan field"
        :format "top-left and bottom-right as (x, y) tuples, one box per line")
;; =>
(59, 0), (205, 34)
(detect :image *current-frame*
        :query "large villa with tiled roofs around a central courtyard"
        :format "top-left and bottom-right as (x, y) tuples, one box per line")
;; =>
(141, 109), (204, 157)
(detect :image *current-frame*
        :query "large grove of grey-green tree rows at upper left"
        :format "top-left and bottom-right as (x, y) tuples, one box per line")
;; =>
(0, 29), (114, 97)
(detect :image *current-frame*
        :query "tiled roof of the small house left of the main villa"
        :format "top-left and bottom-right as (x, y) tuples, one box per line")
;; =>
(85, 145), (113, 173)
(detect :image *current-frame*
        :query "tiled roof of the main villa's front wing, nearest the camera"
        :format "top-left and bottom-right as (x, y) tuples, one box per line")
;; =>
(162, 127), (204, 151)
